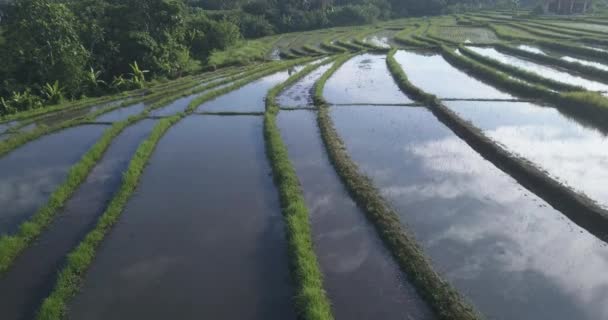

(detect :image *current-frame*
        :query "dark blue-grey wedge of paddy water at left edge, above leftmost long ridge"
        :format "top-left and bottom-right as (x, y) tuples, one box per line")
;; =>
(0, 125), (106, 234)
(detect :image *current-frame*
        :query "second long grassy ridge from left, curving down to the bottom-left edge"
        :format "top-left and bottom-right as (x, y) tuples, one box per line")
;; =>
(37, 58), (311, 320)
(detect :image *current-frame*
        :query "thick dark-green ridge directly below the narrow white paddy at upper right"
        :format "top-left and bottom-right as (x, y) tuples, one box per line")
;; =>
(441, 46), (608, 132)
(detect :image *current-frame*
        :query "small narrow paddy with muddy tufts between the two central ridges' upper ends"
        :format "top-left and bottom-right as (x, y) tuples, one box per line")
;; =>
(277, 63), (332, 108)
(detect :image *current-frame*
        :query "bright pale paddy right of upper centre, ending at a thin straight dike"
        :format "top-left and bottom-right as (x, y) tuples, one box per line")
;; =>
(395, 50), (513, 99)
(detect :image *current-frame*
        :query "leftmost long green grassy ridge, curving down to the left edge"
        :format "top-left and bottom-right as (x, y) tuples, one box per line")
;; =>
(0, 60), (300, 274)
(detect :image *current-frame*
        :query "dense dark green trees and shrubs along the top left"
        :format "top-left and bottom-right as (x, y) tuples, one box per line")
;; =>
(0, 0), (504, 114)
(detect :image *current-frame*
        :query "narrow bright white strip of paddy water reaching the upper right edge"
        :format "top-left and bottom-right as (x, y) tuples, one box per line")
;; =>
(469, 47), (608, 91)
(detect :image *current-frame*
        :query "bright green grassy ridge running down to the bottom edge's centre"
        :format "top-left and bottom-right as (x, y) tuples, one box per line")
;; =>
(264, 60), (334, 320)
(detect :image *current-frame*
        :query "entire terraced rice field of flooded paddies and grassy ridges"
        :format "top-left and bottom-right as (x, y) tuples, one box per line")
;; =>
(0, 13), (608, 320)
